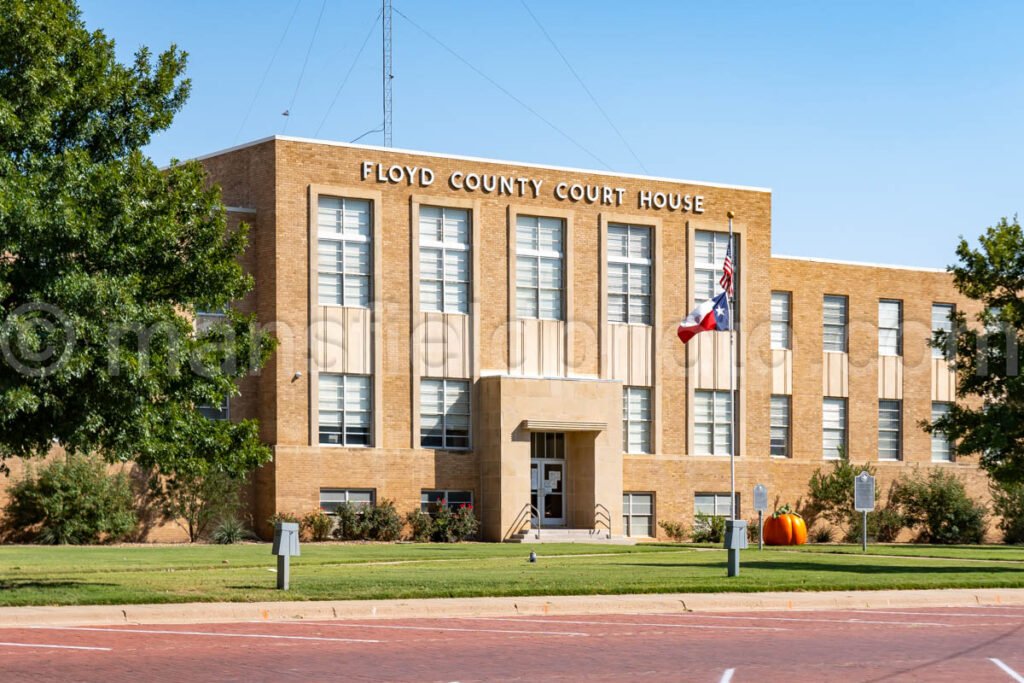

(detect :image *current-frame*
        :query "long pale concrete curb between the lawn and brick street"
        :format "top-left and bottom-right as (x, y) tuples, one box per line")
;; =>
(0, 589), (1024, 628)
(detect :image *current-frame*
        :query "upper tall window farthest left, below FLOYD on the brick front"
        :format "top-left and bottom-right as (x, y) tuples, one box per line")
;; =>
(316, 197), (371, 308)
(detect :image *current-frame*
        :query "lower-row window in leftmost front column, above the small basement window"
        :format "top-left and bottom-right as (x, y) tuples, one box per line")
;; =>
(319, 373), (373, 445)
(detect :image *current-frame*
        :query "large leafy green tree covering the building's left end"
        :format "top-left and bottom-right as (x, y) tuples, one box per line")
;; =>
(0, 0), (273, 475)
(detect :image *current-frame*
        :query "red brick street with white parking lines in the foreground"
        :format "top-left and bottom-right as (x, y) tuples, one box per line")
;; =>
(0, 606), (1024, 683)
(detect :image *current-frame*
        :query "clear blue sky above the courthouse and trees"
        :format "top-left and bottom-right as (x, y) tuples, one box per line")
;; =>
(81, 0), (1024, 267)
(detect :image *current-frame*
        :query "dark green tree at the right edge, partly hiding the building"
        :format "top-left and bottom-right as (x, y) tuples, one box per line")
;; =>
(926, 217), (1024, 483)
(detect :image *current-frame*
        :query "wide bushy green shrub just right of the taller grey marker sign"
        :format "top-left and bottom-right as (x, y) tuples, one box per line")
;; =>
(892, 469), (986, 544)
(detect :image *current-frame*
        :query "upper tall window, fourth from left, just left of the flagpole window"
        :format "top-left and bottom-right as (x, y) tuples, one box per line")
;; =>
(608, 223), (651, 325)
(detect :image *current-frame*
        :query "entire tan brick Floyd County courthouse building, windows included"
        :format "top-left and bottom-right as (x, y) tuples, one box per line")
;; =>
(195, 136), (984, 541)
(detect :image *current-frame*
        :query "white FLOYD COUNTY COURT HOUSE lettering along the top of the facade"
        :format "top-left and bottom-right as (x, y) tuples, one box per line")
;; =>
(360, 161), (705, 213)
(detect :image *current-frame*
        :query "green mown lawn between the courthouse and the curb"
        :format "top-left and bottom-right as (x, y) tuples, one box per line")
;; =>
(0, 544), (1024, 605)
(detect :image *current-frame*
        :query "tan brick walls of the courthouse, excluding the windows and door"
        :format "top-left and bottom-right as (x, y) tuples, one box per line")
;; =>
(0, 137), (985, 540)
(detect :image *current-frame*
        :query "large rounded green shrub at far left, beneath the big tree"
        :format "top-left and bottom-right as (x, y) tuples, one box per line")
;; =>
(3, 456), (138, 545)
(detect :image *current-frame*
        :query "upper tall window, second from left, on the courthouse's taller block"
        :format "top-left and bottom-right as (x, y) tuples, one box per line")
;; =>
(420, 206), (470, 313)
